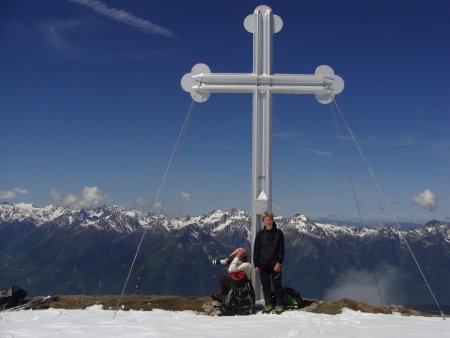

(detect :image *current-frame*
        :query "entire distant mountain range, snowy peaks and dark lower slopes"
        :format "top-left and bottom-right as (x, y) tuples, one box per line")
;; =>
(0, 203), (450, 303)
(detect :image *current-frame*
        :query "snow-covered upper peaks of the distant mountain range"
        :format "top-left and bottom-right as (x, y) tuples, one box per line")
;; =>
(0, 203), (450, 243)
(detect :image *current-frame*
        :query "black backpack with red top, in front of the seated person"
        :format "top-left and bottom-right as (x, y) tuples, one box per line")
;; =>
(221, 271), (255, 316)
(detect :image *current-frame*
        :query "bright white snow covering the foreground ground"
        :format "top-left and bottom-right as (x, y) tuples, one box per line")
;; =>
(0, 305), (450, 338)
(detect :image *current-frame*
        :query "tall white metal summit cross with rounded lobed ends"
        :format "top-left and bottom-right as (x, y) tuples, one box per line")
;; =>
(181, 6), (344, 299)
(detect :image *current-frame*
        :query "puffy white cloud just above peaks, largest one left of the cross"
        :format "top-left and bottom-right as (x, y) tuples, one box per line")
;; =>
(50, 187), (105, 209)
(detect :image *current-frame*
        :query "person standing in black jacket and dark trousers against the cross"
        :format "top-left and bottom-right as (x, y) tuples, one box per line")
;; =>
(253, 212), (284, 314)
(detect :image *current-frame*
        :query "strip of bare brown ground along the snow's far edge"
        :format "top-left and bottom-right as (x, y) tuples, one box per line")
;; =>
(29, 295), (430, 316)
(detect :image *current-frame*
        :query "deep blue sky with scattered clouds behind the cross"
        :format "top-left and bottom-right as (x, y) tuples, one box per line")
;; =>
(0, 0), (450, 222)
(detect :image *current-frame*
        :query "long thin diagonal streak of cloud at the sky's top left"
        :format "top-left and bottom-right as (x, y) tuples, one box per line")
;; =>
(69, 0), (175, 38)
